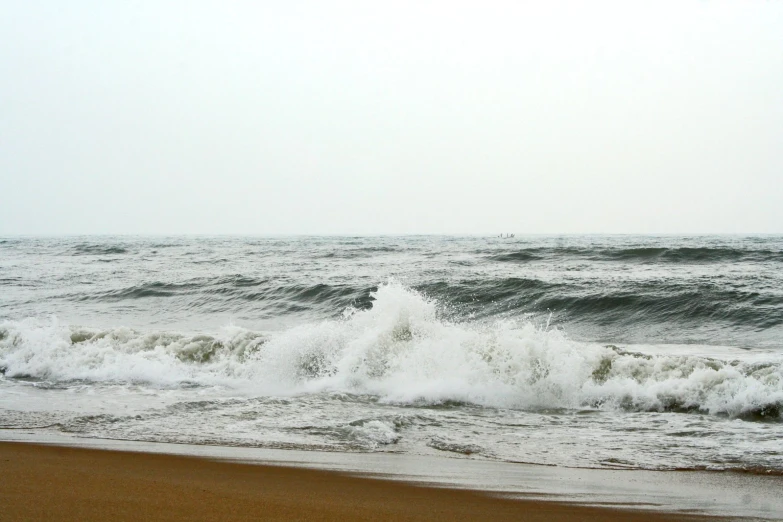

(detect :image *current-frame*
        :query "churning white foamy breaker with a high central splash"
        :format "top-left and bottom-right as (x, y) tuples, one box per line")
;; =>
(0, 283), (783, 416)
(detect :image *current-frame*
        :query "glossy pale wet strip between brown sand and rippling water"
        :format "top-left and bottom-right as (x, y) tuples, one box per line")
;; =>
(0, 428), (783, 520)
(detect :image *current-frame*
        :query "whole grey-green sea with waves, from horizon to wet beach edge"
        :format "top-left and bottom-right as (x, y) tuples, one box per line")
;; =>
(0, 235), (783, 475)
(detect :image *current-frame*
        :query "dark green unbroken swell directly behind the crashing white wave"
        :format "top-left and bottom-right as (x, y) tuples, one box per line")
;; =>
(58, 274), (783, 329)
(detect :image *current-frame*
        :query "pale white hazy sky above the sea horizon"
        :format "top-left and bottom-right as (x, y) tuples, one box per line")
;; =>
(0, 0), (783, 235)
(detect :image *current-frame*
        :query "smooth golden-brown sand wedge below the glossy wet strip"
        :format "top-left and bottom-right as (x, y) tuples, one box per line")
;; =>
(0, 442), (718, 522)
